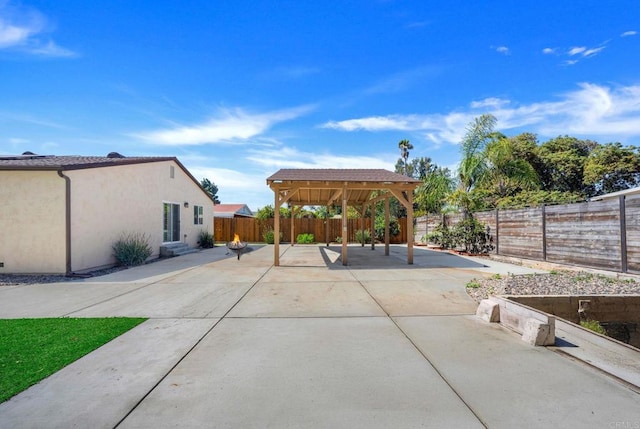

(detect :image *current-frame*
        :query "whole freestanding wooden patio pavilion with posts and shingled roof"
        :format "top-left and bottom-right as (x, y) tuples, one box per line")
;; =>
(267, 169), (420, 266)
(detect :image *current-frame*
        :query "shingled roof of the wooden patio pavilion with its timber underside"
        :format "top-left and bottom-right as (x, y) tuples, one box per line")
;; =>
(267, 168), (420, 206)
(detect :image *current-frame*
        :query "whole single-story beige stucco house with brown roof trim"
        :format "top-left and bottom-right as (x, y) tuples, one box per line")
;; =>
(0, 153), (214, 274)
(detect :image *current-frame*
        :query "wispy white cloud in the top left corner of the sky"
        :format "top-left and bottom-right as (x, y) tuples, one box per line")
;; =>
(0, 2), (76, 57)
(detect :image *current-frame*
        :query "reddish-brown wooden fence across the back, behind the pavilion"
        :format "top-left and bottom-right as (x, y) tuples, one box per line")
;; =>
(213, 218), (407, 244)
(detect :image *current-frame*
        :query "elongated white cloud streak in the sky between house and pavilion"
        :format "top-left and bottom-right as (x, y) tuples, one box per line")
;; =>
(134, 106), (313, 146)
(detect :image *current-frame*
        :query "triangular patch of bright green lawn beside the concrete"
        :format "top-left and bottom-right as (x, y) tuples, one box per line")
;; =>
(0, 318), (146, 402)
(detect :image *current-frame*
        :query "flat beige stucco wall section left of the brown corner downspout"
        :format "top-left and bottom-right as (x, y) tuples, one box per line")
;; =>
(0, 171), (66, 274)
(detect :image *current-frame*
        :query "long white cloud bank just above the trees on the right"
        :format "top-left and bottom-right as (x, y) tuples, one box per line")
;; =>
(323, 83), (640, 143)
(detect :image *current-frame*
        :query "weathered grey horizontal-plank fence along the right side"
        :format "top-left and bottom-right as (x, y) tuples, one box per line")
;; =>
(415, 196), (640, 274)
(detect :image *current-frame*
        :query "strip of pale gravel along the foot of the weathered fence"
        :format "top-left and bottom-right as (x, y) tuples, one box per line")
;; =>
(467, 271), (640, 302)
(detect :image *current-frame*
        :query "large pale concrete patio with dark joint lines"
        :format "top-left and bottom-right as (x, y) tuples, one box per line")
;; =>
(0, 246), (640, 428)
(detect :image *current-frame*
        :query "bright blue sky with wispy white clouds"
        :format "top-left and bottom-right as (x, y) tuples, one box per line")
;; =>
(0, 0), (640, 210)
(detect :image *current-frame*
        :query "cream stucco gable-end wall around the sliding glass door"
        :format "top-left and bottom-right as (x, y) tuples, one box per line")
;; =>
(66, 161), (213, 272)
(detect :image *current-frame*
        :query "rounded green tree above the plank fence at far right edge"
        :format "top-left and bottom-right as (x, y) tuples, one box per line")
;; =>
(584, 143), (640, 195)
